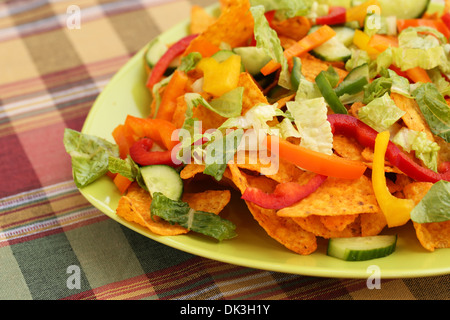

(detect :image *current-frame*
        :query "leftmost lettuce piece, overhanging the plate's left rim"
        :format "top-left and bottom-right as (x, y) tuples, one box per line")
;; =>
(63, 128), (119, 188)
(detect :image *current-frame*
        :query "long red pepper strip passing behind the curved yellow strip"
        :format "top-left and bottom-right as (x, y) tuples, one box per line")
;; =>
(328, 114), (450, 183)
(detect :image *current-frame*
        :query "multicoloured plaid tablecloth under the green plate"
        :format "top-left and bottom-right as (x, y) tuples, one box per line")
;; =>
(0, 0), (450, 300)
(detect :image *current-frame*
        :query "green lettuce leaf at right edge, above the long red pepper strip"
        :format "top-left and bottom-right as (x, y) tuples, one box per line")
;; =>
(412, 83), (450, 142)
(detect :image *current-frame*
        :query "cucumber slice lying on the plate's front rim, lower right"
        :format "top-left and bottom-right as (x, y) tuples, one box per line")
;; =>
(327, 235), (397, 261)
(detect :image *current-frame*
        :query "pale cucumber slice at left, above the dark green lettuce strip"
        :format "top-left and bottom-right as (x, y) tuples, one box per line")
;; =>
(141, 164), (183, 200)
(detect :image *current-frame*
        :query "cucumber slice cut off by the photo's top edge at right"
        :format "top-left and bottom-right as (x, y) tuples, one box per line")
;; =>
(378, 0), (430, 19)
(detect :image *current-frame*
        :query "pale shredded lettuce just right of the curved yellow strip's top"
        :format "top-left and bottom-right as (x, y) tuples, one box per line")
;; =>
(392, 127), (440, 172)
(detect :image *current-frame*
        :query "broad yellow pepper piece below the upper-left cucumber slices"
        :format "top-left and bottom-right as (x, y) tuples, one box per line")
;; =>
(197, 54), (241, 97)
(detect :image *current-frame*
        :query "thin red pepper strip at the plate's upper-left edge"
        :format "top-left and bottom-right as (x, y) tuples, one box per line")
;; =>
(147, 34), (198, 90)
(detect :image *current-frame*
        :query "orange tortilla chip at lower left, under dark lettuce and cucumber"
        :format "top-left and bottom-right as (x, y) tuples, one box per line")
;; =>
(116, 182), (188, 236)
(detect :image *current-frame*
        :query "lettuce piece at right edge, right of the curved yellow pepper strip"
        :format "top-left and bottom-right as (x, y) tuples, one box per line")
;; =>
(411, 180), (450, 223)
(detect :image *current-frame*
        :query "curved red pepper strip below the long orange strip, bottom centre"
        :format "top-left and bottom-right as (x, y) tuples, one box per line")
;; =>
(241, 174), (327, 210)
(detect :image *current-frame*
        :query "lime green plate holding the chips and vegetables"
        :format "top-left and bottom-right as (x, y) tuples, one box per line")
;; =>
(80, 6), (450, 278)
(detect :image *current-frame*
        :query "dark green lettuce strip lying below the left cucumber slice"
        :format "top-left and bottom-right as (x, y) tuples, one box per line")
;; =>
(150, 192), (236, 241)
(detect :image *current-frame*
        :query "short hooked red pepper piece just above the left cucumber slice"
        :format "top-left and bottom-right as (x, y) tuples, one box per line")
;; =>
(130, 138), (174, 166)
